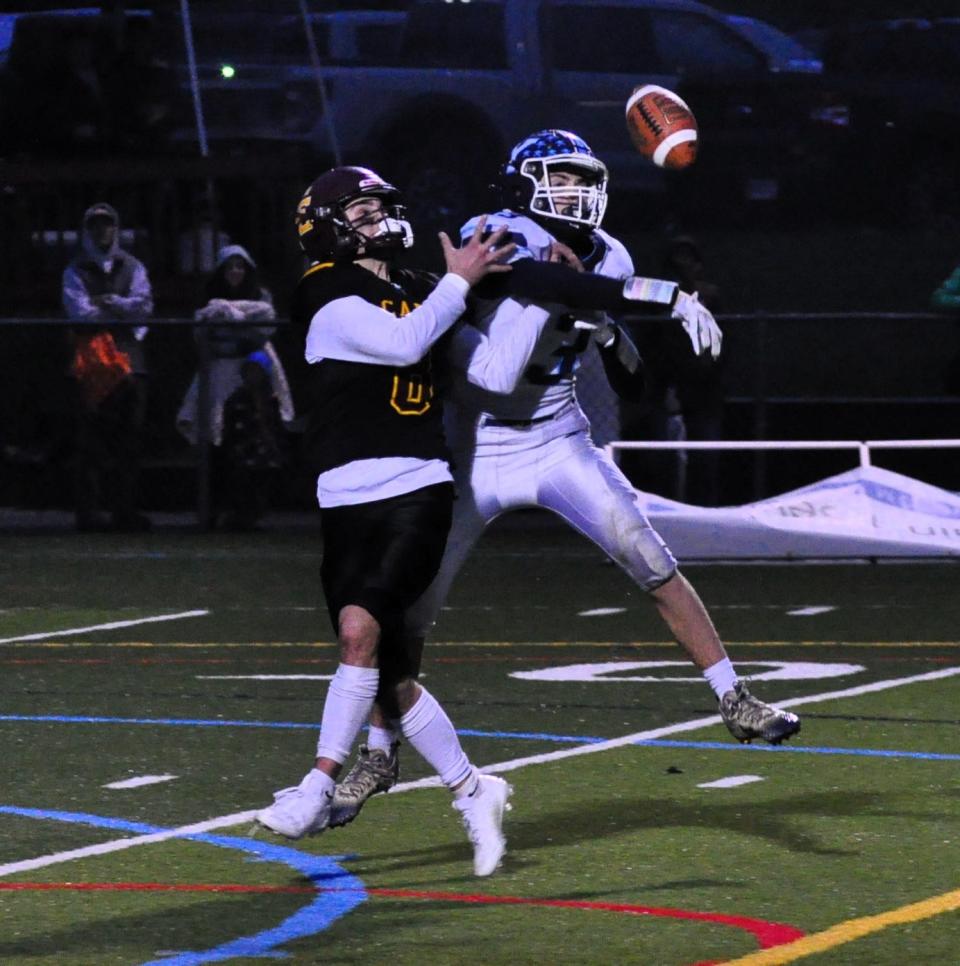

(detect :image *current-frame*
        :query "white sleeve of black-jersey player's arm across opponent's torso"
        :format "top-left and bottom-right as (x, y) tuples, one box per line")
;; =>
(448, 299), (550, 393)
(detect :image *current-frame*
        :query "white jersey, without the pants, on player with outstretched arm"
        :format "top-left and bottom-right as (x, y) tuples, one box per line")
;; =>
(449, 211), (633, 430)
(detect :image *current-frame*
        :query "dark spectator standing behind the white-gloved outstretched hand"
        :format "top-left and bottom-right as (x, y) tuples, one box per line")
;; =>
(624, 235), (725, 506)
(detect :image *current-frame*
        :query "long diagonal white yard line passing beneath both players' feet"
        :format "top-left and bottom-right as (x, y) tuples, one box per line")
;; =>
(0, 667), (960, 877)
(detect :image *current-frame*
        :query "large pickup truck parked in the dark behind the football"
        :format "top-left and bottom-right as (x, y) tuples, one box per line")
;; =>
(288, 0), (844, 227)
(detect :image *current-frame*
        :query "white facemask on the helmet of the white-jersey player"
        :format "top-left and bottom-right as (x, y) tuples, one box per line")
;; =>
(519, 154), (608, 229)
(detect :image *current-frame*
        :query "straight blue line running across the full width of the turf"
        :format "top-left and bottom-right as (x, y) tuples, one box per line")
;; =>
(0, 714), (960, 761)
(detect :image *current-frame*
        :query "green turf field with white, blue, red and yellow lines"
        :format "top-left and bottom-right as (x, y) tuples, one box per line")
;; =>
(0, 516), (960, 966)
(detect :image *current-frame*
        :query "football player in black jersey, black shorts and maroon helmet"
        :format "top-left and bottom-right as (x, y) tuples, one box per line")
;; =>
(257, 167), (528, 875)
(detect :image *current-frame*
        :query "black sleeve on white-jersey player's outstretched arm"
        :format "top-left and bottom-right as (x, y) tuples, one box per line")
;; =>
(476, 258), (670, 314)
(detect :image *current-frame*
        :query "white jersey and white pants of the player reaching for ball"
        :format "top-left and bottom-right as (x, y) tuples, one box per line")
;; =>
(405, 212), (677, 638)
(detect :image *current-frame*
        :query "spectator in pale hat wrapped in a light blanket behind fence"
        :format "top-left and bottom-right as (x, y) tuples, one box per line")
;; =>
(177, 245), (294, 524)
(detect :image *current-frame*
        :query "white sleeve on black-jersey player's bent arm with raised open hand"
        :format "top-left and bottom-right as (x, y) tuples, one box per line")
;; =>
(305, 273), (469, 366)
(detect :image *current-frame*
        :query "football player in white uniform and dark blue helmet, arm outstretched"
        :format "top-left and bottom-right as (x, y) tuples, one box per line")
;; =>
(331, 130), (800, 825)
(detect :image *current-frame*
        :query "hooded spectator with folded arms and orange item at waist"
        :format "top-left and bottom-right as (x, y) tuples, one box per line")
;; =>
(63, 202), (153, 531)
